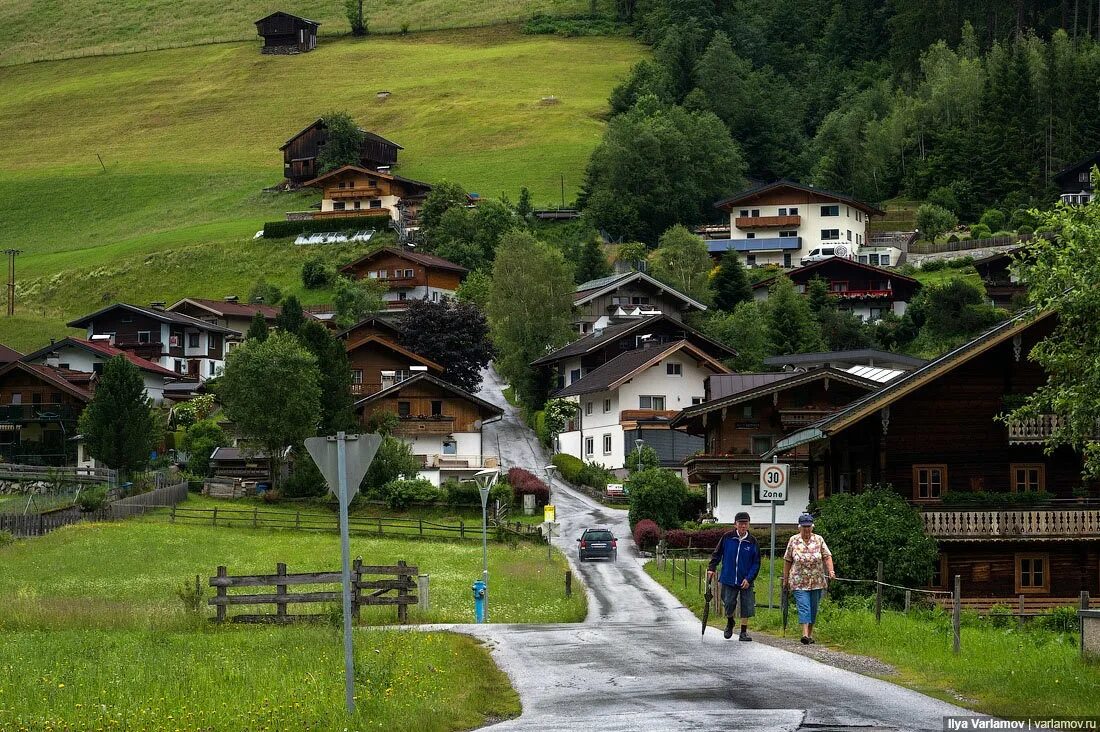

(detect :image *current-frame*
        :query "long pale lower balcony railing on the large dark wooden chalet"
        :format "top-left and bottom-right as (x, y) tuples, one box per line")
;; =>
(921, 509), (1100, 539)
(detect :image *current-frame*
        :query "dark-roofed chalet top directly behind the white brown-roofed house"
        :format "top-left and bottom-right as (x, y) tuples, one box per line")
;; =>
(531, 315), (737, 389)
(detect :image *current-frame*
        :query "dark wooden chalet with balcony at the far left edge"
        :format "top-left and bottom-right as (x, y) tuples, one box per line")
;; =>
(0, 361), (95, 466)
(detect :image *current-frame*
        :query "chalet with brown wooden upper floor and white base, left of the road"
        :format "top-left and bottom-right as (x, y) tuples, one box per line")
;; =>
(355, 372), (504, 485)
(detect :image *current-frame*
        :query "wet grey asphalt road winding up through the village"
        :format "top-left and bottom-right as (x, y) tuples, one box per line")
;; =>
(435, 371), (968, 732)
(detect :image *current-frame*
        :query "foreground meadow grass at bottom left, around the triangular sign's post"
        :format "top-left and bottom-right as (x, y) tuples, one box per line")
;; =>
(0, 626), (520, 732)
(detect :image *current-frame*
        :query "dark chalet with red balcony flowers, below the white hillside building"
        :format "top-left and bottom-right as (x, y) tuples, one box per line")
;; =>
(752, 256), (921, 323)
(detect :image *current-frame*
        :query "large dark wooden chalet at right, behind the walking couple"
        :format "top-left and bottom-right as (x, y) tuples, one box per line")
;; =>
(765, 312), (1100, 608)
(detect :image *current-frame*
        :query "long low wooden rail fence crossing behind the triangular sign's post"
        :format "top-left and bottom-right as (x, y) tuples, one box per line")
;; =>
(168, 505), (541, 539)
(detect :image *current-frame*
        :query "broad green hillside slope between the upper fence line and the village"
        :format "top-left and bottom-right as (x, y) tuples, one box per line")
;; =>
(0, 28), (642, 349)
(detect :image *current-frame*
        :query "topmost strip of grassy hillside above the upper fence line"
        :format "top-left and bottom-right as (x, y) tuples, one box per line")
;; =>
(0, 0), (609, 66)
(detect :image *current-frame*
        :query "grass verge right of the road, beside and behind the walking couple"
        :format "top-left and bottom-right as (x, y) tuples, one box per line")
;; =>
(646, 560), (1100, 718)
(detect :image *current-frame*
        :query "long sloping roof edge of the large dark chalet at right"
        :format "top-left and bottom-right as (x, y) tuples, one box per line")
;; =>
(766, 309), (1054, 457)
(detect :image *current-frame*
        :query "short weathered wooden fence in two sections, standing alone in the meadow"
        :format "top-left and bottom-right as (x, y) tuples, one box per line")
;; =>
(208, 557), (419, 624)
